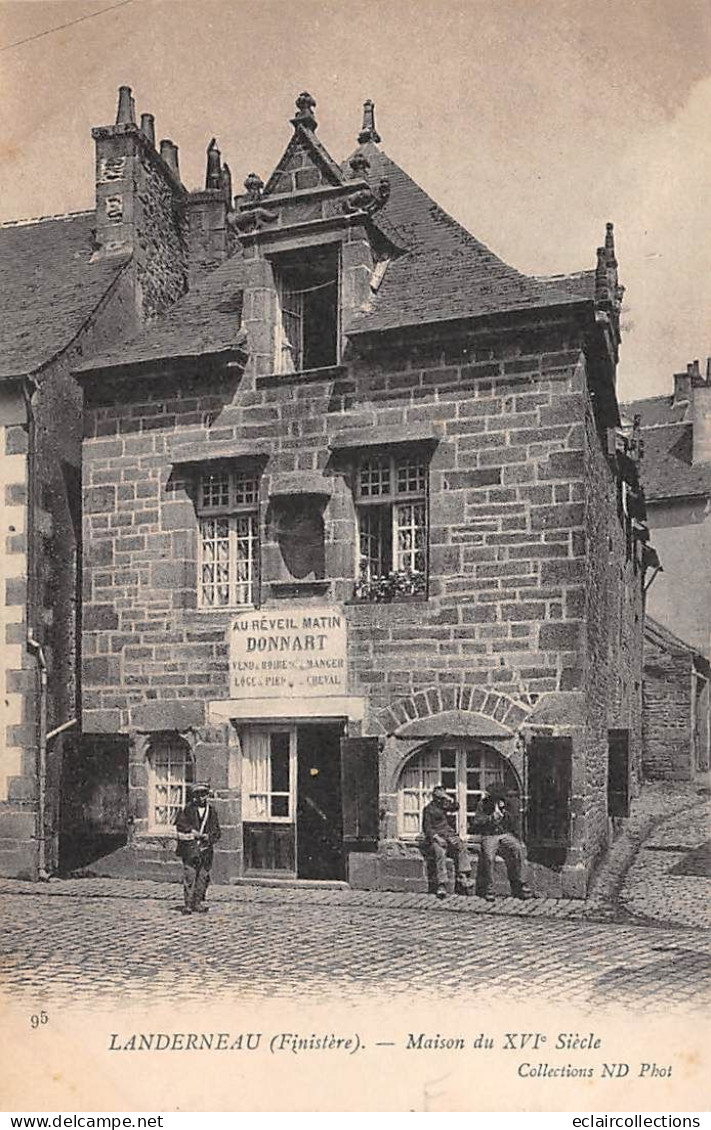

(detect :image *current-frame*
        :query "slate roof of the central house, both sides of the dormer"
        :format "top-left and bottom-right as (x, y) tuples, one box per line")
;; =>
(76, 131), (595, 373)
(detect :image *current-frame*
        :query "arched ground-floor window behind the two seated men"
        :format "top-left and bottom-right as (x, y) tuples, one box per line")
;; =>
(398, 738), (520, 840)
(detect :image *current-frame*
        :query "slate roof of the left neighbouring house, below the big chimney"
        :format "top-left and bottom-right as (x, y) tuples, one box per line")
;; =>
(0, 211), (128, 381)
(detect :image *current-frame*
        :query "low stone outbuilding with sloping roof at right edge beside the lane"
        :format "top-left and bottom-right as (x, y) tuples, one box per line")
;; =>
(642, 617), (711, 788)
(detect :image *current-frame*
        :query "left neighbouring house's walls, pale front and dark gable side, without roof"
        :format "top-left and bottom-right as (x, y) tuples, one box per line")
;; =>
(0, 264), (135, 876)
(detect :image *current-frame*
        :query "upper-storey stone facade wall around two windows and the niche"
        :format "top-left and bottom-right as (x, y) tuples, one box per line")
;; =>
(84, 314), (601, 729)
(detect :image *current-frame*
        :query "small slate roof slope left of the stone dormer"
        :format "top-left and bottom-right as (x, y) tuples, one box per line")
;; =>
(75, 255), (246, 373)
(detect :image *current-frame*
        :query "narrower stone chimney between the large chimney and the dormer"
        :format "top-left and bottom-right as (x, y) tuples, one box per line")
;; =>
(188, 138), (236, 286)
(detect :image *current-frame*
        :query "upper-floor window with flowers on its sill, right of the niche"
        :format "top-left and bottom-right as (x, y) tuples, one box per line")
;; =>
(355, 450), (428, 601)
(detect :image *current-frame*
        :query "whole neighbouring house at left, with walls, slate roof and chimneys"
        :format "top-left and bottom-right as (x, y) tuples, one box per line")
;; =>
(0, 87), (229, 875)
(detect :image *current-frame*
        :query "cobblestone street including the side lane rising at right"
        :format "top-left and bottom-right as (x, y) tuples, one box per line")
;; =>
(0, 786), (711, 1011)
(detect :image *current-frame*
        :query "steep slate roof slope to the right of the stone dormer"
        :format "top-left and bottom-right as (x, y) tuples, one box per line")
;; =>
(343, 141), (592, 333)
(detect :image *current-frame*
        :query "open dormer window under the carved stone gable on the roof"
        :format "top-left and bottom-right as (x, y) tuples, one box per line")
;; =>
(272, 244), (340, 374)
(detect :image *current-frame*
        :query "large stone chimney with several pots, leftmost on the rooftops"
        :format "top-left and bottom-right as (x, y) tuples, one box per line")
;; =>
(92, 86), (188, 320)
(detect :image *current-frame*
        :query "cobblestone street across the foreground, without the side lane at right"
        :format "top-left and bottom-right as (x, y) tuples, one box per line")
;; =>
(1, 880), (711, 1011)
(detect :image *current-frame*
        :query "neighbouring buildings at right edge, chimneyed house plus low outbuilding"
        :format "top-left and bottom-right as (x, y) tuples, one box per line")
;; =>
(623, 360), (711, 784)
